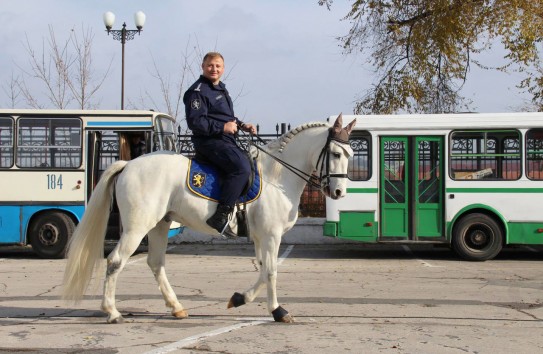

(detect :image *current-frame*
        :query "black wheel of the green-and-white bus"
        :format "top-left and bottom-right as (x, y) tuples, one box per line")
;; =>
(452, 213), (503, 261)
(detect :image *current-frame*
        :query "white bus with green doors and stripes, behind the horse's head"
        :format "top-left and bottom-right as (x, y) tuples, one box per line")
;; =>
(324, 113), (543, 260)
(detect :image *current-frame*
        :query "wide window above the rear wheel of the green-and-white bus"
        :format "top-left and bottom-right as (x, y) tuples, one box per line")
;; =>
(449, 130), (521, 180)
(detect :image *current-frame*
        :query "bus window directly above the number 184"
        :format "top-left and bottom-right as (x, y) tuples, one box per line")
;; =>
(17, 118), (81, 169)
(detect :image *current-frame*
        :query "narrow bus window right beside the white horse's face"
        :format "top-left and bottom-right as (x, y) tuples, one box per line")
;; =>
(347, 130), (371, 181)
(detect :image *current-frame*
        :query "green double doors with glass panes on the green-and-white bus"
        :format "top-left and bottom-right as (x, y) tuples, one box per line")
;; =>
(379, 136), (444, 241)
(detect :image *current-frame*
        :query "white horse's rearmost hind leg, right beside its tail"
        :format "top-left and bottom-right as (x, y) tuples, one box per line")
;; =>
(101, 231), (145, 323)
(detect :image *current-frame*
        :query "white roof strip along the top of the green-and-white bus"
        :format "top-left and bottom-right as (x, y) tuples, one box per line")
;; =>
(328, 112), (543, 131)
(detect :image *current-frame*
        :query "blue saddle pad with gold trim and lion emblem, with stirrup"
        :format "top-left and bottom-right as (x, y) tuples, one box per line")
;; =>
(187, 154), (262, 237)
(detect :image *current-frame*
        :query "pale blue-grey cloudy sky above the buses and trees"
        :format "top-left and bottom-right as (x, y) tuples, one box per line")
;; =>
(0, 0), (527, 133)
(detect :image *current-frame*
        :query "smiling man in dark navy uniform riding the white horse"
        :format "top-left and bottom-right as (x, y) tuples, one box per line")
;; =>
(183, 52), (256, 232)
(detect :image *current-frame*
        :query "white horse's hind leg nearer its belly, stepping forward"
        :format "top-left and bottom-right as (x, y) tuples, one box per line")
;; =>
(147, 221), (189, 318)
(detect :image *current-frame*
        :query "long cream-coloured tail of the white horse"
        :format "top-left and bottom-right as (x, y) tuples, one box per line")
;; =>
(62, 161), (127, 301)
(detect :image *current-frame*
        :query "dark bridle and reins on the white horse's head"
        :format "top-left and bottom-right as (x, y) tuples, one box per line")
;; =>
(244, 128), (349, 190)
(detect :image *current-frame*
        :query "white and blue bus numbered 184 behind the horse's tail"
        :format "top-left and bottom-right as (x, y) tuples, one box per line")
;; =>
(0, 110), (181, 258)
